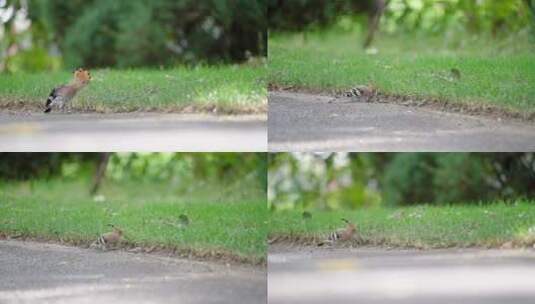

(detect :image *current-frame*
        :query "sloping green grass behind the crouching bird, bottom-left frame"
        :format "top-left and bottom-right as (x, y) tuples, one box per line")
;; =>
(0, 180), (267, 264)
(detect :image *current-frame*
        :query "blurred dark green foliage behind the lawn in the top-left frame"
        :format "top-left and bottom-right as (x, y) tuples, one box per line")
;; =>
(0, 0), (267, 72)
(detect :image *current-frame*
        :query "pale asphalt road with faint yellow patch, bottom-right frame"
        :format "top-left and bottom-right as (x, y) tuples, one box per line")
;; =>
(268, 246), (535, 304)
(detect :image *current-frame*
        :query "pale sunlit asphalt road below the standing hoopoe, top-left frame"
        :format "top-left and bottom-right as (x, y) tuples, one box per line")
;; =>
(0, 112), (267, 152)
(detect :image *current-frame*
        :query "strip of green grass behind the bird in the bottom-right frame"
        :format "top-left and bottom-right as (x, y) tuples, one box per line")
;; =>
(269, 201), (535, 248)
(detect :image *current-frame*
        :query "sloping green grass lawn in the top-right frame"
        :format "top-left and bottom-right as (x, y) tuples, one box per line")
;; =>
(268, 30), (535, 117)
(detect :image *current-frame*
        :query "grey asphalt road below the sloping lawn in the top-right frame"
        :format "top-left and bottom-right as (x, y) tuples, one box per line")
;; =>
(268, 92), (535, 152)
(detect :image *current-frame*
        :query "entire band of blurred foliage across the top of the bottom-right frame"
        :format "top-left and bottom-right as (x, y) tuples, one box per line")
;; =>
(268, 153), (535, 209)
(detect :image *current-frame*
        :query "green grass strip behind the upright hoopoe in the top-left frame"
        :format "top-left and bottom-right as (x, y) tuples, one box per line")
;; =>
(0, 64), (267, 113)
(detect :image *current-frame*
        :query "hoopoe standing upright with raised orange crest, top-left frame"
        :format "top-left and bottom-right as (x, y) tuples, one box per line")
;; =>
(45, 69), (91, 113)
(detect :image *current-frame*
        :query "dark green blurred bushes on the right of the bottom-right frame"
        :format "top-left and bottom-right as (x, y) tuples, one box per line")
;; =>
(381, 153), (535, 204)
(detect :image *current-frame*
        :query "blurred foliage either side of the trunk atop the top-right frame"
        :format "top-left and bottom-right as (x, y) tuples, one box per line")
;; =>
(268, 0), (535, 35)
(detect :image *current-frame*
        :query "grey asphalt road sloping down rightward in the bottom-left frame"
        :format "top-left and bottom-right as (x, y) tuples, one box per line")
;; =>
(0, 241), (267, 304)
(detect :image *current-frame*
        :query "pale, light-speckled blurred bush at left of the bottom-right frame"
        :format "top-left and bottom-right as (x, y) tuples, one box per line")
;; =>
(268, 153), (380, 210)
